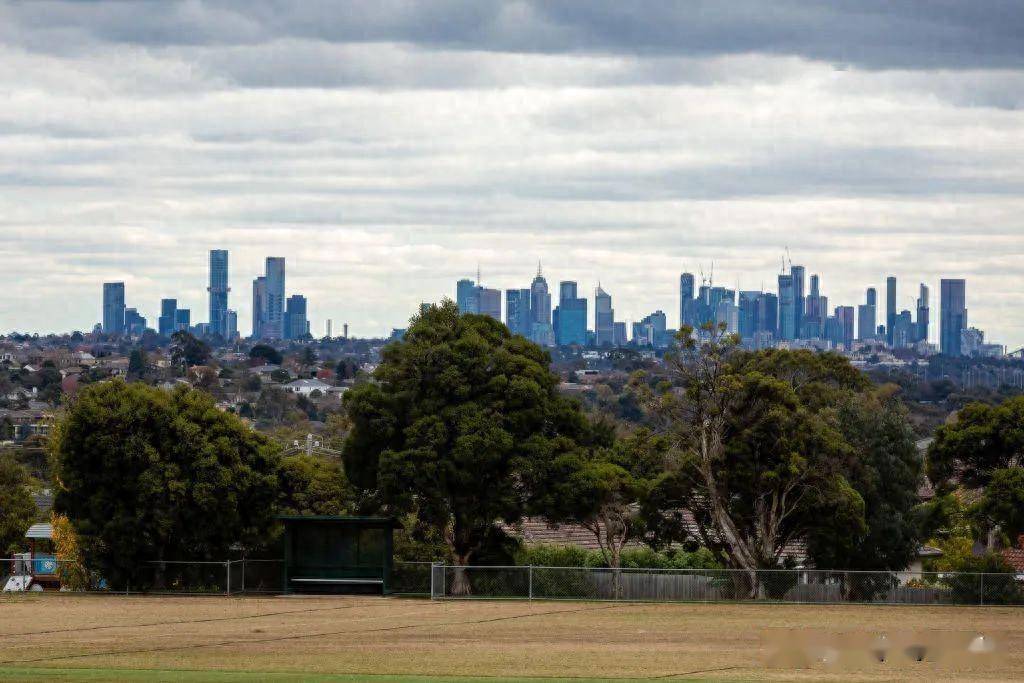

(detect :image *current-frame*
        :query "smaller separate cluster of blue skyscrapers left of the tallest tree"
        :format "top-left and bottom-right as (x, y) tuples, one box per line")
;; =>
(102, 249), (309, 340)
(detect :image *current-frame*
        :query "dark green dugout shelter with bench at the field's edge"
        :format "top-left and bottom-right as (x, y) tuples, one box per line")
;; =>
(280, 516), (397, 595)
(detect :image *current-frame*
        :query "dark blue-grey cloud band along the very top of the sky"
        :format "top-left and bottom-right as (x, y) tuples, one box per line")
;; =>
(6, 0), (1024, 69)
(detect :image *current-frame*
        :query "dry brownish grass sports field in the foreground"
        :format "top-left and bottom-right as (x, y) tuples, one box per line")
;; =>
(0, 594), (1024, 683)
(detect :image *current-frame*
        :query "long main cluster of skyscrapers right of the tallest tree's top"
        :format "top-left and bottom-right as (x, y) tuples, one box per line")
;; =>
(456, 263), (992, 355)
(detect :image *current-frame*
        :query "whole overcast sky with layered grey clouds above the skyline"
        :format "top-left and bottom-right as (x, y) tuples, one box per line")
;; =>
(0, 0), (1024, 348)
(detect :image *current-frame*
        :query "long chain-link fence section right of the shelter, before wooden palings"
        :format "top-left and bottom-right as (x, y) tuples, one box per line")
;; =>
(430, 563), (1024, 605)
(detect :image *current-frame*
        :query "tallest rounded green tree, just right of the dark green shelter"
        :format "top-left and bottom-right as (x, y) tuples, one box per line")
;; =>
(344, 301), (589, 590)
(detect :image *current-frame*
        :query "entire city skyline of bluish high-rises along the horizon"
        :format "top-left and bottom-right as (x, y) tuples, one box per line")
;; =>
(86, 249), (1011, 354)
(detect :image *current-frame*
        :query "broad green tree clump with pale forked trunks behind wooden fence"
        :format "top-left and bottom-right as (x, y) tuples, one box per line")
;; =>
(648, 327), (920, 590)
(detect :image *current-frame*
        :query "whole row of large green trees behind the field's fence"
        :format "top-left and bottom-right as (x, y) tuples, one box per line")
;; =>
(4, 302), (1024, 590)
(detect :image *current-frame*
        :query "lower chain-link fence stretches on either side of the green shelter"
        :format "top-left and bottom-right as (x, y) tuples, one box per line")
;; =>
(0, 553), (431, 597)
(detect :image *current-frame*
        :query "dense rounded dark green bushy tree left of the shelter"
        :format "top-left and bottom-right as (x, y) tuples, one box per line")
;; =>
(52, 381), (279, 585)
